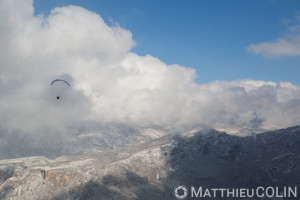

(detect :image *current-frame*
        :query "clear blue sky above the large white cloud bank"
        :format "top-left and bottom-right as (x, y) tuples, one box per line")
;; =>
(34, 0), (300, 85)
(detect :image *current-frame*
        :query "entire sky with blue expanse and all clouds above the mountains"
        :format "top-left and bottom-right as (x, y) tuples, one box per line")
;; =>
(0, 0), (300, 142)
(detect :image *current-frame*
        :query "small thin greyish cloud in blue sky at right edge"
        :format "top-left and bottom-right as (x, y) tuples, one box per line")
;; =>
(248, 17), (300, 58)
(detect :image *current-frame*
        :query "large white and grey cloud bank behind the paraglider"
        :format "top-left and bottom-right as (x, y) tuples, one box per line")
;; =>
(0, 0), (300, 138)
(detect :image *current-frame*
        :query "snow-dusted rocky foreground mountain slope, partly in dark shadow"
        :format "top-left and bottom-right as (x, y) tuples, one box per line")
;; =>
(0, 126), (300, 200)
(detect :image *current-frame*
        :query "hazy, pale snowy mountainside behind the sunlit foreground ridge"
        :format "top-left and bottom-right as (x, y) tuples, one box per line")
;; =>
(0, 124), (167, 159)
